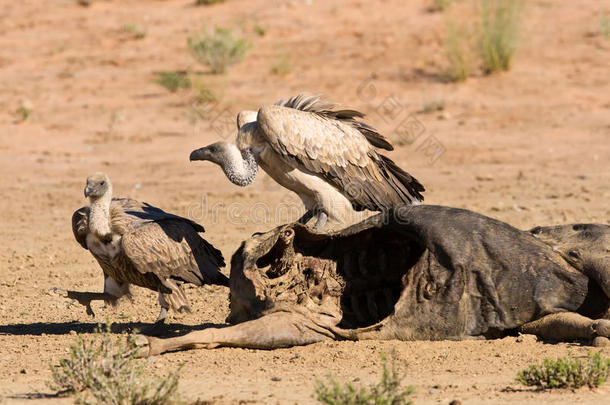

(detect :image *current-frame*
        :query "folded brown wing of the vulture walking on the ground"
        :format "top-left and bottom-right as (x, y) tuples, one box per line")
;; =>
(121, 218), (229, 286)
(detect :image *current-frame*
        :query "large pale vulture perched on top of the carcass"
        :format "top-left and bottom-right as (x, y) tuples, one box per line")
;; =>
(190, 94), (424, 229)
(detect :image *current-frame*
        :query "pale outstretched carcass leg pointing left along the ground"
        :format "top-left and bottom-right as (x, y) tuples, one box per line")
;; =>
(136, 312), (333, 357)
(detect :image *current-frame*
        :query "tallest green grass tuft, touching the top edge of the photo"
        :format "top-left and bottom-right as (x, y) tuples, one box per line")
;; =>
(480, 0), (521, 74)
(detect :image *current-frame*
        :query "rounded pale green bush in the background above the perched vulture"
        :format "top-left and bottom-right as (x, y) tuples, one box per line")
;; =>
(187, 27), (250, 73)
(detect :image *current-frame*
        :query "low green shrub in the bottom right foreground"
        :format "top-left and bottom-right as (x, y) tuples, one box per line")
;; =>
(517, 352), (610, 389)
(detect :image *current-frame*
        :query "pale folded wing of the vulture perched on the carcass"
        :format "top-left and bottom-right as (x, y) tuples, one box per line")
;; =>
(257, 96), (424, 211)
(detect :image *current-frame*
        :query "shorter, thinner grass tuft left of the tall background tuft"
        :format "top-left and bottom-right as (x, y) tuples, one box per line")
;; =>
(444, 19), (471, 82)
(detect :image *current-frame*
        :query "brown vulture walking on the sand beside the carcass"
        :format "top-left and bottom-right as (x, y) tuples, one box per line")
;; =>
(60, 173), (229, 324)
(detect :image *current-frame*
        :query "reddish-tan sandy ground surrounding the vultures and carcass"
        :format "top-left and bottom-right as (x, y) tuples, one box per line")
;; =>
(0, 0), (610, 404)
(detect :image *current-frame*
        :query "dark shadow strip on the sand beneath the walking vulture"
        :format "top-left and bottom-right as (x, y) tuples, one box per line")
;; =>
(0, 322), (229, 337)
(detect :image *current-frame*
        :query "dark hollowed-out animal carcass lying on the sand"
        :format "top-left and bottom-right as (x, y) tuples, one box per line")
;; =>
(138, 205), (610, 355)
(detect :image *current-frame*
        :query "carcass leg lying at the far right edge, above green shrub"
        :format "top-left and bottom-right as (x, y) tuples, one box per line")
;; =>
(519, 312), (610, 345)
